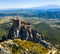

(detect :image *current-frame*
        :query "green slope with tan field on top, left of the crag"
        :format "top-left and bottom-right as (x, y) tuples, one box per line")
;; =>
(0, 18), (11, 40)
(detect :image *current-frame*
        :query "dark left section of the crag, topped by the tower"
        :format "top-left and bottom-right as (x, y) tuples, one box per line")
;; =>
(7, 17), (20, 39)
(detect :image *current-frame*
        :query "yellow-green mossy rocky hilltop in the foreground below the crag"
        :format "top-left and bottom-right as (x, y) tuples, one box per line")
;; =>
(0, 39), (48, 54)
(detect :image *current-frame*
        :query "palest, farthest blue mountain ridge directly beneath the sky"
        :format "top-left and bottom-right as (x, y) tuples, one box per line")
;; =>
(0, 5), (60, 11)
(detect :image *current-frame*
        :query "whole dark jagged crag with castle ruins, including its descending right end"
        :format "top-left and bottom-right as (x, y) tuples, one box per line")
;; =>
(2, 18), (48, 47)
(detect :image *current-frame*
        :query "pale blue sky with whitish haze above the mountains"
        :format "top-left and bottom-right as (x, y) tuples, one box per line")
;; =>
(0, 0), (60, 9)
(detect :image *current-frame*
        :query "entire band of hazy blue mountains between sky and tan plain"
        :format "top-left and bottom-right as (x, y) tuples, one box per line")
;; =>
(0, 5), (60, 18)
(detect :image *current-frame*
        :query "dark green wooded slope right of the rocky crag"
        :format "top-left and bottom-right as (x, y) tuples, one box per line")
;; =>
(34, 23), (60, 44)
